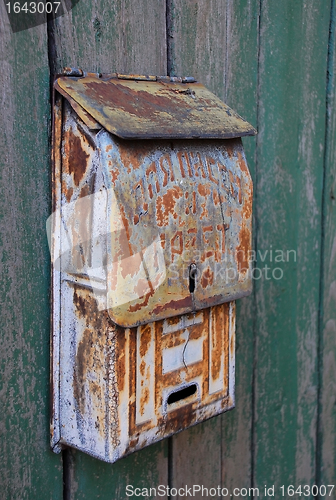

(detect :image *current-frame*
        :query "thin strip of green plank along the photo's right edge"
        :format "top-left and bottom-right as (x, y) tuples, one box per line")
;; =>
(317, 1), (336, 485)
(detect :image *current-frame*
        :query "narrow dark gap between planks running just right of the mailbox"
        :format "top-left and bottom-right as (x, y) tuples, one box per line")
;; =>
(250, 0), (263, 498)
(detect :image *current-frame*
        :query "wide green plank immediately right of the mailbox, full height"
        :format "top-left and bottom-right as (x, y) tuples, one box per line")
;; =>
(254, 0), (330, 491)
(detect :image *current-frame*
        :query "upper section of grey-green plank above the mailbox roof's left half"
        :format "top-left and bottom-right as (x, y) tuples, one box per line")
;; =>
(52, 0), (167, 75)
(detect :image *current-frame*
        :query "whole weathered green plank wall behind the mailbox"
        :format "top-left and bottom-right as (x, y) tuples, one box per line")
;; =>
(0, 0), (336, 500)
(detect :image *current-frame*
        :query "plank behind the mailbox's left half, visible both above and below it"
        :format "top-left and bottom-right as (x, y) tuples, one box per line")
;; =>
(50, 0), (168, 500)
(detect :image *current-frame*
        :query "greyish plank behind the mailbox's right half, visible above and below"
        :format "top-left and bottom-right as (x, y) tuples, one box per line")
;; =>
(169, 0), (258, 491)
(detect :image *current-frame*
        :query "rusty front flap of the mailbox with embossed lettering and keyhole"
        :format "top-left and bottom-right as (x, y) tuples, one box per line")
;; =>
(97, 130), (252, 327)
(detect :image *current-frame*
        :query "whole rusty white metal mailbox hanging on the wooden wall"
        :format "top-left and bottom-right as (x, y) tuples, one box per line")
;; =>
(49, 70), (255, 462)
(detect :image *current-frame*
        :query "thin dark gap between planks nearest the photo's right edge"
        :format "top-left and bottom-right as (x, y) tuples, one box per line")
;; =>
(315, 0), (336, 492)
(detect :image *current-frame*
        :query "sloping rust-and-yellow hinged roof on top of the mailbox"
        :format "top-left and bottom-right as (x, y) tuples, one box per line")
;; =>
(55, 74), (256, 139)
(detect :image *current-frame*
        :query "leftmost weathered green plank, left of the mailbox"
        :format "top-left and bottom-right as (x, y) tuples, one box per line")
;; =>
(0, 3), (63, 500)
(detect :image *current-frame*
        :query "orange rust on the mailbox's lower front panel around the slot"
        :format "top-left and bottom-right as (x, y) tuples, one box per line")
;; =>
(125, 304), (229, 449)
